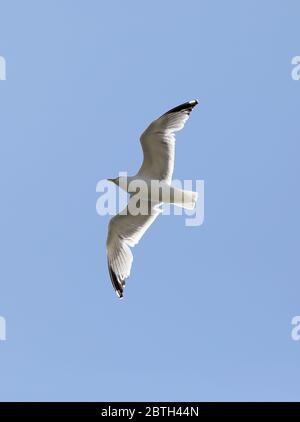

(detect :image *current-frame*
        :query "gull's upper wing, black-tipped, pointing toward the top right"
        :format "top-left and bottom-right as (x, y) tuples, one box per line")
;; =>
(138, 100), (198, 182)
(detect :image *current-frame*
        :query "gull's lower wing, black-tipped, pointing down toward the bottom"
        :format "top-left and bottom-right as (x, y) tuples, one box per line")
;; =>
(106, 200), (161, 298)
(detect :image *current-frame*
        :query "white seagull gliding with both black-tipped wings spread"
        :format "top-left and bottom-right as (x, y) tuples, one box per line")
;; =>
(106, 100), (198, 298)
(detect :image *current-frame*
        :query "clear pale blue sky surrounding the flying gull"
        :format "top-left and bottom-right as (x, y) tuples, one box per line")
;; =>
(0, 0), (300, 401)
